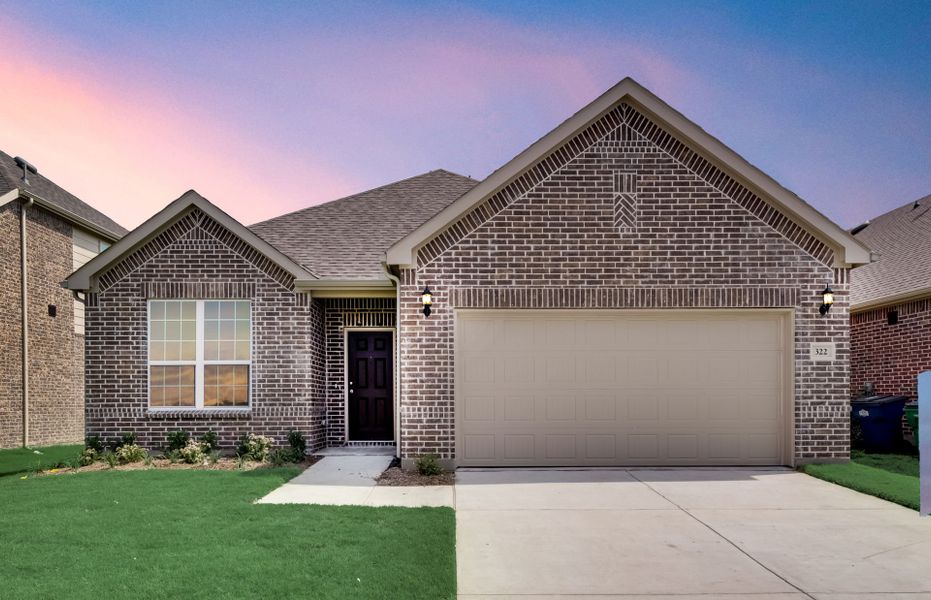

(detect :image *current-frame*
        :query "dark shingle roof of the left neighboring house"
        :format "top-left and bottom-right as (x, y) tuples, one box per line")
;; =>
(0, 151), (127, 242)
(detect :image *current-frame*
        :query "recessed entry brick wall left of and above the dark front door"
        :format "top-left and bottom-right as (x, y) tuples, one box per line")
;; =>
(323, 298), (397, 446)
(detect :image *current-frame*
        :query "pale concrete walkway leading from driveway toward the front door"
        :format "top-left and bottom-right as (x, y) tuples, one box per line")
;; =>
(257, 454), (453, 507)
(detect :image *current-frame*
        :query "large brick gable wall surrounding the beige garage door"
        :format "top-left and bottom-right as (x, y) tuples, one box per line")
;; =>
(400, 104), (849, 461)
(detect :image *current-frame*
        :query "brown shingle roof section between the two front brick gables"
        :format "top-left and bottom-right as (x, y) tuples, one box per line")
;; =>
(249, 169), (478, 280)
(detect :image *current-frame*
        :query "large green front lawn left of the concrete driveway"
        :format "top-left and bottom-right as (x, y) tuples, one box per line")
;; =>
(0, 468), (456, 600)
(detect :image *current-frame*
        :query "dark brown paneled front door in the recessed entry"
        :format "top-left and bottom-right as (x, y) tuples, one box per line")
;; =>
(347, 331), (394, 442)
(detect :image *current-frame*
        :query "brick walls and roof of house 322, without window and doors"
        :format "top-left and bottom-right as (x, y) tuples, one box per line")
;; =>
(69, 80), (868, 464)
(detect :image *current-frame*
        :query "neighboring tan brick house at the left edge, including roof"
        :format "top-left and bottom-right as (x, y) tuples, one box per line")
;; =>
(0, 152), (126, 448)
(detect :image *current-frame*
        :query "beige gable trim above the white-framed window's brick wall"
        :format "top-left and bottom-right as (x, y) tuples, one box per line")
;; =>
(62, 190), (316, 291)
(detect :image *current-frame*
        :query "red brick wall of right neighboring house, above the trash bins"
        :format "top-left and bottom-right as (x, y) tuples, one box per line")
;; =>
(850, 298), (931, 398)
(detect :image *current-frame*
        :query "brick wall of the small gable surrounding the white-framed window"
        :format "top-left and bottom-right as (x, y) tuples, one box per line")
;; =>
(86, 209), (326, 449)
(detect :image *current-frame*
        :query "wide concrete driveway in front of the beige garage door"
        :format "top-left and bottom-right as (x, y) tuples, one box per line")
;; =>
(456, 469), (931, 600)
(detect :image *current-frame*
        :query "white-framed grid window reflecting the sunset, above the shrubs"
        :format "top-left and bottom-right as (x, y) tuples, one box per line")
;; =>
(149, 300), (252, 409)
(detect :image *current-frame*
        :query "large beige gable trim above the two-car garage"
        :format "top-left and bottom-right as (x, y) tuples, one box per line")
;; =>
(386, 77), (870, 267)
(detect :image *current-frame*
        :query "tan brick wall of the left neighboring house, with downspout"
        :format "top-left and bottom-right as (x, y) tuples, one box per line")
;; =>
(0, 201), (84, 448)
